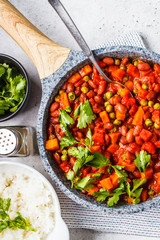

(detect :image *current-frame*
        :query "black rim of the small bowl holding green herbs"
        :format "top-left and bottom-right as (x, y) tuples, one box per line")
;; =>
(0, 53), (30, 122)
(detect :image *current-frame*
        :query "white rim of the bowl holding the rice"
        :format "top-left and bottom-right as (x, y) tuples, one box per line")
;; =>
(0, 161), (69, 240)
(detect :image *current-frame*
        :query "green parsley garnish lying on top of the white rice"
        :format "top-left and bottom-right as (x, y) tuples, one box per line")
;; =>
(0, 198), (37, 232)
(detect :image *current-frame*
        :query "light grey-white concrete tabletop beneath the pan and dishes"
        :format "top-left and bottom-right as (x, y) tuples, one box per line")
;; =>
(0, 0), (160, 240)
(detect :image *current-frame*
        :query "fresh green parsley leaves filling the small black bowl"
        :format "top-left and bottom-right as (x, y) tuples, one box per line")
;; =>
(0, 63), (26, 115)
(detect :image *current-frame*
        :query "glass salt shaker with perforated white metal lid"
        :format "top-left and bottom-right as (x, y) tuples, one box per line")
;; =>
(0, 126), (34, 157)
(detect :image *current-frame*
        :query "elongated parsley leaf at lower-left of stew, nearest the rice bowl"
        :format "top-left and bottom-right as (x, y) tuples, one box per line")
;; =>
(74, 173), (101, 190)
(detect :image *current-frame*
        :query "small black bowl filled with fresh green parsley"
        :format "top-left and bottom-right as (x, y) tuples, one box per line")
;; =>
(0, 54), (29, 122)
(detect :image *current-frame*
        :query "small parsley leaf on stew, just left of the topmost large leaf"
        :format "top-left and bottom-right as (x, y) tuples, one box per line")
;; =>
(58, 110), (75, 132)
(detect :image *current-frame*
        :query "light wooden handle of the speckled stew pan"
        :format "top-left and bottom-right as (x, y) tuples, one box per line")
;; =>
(0, 0), (70, 79)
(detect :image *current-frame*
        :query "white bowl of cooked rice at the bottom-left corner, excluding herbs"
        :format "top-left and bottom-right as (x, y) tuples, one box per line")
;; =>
(0, 161), (69, 240)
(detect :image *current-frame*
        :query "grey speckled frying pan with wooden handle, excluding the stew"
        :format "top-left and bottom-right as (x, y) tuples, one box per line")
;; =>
(0, 0), (160, 213)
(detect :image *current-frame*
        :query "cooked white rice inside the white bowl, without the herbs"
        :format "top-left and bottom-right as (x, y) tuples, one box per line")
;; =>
(0, 168), (54, 240)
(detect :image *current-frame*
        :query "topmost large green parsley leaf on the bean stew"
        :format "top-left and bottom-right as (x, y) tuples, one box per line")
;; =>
(74, 100), (95, 129)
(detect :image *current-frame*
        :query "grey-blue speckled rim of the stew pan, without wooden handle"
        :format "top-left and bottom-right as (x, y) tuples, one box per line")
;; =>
(37, 46), (160, 214)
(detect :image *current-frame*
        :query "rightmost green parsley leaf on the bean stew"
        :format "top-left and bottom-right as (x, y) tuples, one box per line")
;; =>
(134, 150), (151, 173)
